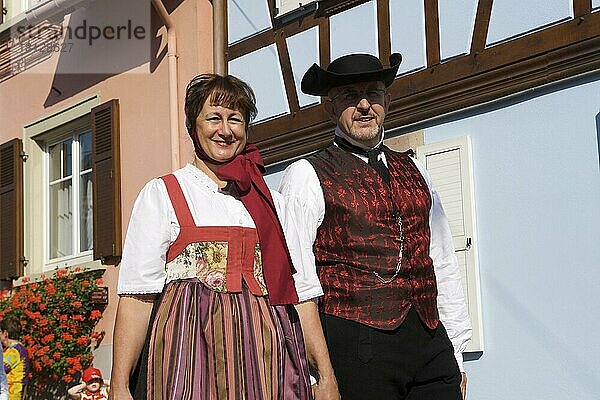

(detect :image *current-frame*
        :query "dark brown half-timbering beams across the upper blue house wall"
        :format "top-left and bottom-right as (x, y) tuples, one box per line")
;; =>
(225, 0), (600, 164)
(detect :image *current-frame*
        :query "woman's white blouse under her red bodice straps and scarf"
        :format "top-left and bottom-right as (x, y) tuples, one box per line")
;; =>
(117, 164), (285, 295)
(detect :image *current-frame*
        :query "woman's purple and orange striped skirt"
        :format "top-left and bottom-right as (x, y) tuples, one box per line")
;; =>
(147, 279), (312, 400)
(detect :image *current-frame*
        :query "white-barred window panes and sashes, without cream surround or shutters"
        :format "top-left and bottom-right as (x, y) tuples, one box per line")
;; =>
(46, 126), (93, 264)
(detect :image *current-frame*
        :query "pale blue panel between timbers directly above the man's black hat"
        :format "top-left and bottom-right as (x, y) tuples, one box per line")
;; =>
(329, 0), (378, 62)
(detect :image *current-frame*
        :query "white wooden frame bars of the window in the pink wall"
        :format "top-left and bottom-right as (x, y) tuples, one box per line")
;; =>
(43, 128), (94, 271)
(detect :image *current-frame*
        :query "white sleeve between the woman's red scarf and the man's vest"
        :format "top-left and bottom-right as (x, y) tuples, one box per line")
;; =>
(278, 160), (325, 301)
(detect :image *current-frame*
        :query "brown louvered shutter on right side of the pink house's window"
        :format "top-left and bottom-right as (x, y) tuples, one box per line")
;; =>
(91, 99), (122, 264)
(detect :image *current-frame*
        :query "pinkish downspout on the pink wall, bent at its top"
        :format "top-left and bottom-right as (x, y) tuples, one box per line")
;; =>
(152, 0), (180, 171)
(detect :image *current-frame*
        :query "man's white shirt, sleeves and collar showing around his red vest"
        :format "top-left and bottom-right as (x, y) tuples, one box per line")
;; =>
(279, 153), (472, 371)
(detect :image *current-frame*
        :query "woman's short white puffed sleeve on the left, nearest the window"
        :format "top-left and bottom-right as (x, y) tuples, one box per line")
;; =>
(117, 179), (171, 295)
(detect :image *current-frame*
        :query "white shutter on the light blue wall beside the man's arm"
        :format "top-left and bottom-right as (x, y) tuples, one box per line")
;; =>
(416, 136), (483, 351)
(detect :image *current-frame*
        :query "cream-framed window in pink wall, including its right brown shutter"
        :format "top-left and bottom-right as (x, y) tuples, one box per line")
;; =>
(19, 95), (122, 278)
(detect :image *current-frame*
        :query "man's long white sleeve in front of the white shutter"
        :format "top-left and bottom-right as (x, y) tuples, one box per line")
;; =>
(413, 160), (473, 372)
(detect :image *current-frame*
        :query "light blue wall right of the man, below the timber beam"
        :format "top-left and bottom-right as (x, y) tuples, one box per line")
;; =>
(414, 77), (600, 400)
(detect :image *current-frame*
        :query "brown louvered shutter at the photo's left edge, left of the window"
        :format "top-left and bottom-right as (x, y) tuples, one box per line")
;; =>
(0, 139), (24, 279)
